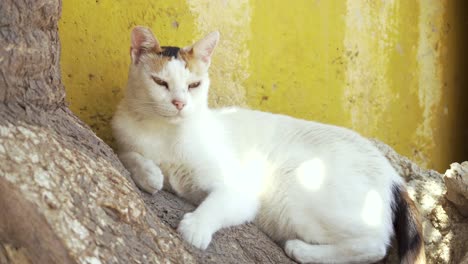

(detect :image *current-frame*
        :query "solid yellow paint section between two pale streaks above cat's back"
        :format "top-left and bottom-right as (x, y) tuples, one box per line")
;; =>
(244, 0), (349, 125)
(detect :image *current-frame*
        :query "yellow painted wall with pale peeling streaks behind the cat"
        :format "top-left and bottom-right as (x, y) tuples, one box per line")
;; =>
(60, 0), (464, 170)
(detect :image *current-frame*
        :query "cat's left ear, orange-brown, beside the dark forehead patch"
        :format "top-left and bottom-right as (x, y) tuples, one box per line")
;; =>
(130, 26), (161, 64)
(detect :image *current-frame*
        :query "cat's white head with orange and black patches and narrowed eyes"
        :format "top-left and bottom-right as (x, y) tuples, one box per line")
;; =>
(126, 26), (219, 122)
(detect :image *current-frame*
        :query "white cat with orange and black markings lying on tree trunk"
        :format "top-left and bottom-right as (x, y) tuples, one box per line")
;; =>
(112, 27), (425, 263)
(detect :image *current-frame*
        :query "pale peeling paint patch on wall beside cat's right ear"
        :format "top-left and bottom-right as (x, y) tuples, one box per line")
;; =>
(188, 0), (251, 107)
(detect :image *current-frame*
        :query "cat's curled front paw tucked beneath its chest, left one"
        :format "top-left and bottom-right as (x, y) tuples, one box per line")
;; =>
(131, 160), (164, 194)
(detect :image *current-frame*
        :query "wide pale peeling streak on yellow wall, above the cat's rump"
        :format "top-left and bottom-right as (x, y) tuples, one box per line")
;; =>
(343, 0), (398, 136)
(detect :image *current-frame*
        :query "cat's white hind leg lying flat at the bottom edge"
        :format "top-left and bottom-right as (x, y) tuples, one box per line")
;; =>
(284, 238), (387, 264)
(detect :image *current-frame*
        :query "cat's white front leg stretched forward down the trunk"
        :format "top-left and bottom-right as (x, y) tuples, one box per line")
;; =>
(178, 188), (259, 249)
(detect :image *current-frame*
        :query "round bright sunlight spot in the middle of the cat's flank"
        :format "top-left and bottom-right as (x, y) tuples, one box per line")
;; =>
(297, 158), (325, 191)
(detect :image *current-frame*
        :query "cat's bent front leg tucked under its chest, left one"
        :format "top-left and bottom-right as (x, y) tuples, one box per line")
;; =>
(119, 152), (164, 194)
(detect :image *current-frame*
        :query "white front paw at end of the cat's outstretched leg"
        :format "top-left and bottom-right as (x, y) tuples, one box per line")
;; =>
(177, 213), (213, 250)
